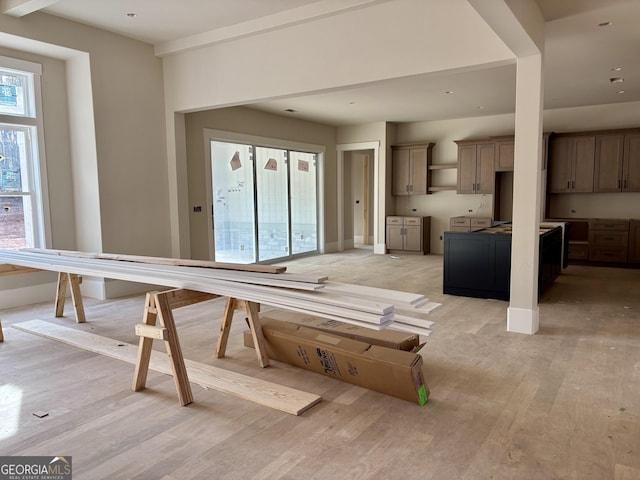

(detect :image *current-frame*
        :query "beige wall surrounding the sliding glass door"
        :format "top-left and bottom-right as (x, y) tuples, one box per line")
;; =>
(185, 107), (338, 259)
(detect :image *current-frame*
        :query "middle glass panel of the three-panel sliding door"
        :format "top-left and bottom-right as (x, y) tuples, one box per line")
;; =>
(256, 147), (289, 262)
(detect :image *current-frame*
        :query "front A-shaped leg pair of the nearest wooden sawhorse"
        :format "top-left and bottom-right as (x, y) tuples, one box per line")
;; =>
(132, 292), (193, 405)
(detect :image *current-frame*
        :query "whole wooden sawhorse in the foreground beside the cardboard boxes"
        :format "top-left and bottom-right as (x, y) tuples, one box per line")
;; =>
(131, 289), (269, 405)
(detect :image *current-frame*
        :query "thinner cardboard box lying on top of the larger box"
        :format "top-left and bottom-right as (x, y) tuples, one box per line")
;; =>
(265, 310), (420, 352)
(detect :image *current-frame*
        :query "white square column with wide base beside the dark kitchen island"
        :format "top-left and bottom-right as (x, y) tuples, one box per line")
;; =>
(507, 54), (543, 334)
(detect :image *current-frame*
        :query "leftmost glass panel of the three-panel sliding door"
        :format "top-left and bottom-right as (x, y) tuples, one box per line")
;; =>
(211, 141), (257, 263)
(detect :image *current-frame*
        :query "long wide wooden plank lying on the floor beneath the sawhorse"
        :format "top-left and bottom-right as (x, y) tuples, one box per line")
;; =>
(12, 320), (321, 415)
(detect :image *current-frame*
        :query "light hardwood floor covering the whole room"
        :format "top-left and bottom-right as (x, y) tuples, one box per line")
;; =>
(0, 249), (640, 480)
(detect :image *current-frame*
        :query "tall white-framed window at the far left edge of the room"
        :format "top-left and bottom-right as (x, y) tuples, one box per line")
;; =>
(0, 57), (45, 249)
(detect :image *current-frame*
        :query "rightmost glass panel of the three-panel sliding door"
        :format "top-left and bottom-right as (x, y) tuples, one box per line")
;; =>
(289, 151), (318, 254)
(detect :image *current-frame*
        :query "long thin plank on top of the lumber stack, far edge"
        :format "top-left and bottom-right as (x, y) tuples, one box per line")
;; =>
(21, 248), (287, 274)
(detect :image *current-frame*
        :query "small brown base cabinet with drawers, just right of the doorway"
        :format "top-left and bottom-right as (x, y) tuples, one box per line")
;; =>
(386, 216), (431, 255)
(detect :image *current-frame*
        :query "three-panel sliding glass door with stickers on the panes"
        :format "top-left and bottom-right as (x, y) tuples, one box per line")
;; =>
(211, 140), (318, 263)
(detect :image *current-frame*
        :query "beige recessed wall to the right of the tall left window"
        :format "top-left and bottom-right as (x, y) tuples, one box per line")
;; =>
(0, 13), (171, 306)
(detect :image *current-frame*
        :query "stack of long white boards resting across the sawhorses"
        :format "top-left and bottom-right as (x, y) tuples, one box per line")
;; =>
(0, 249), (441, 335)
